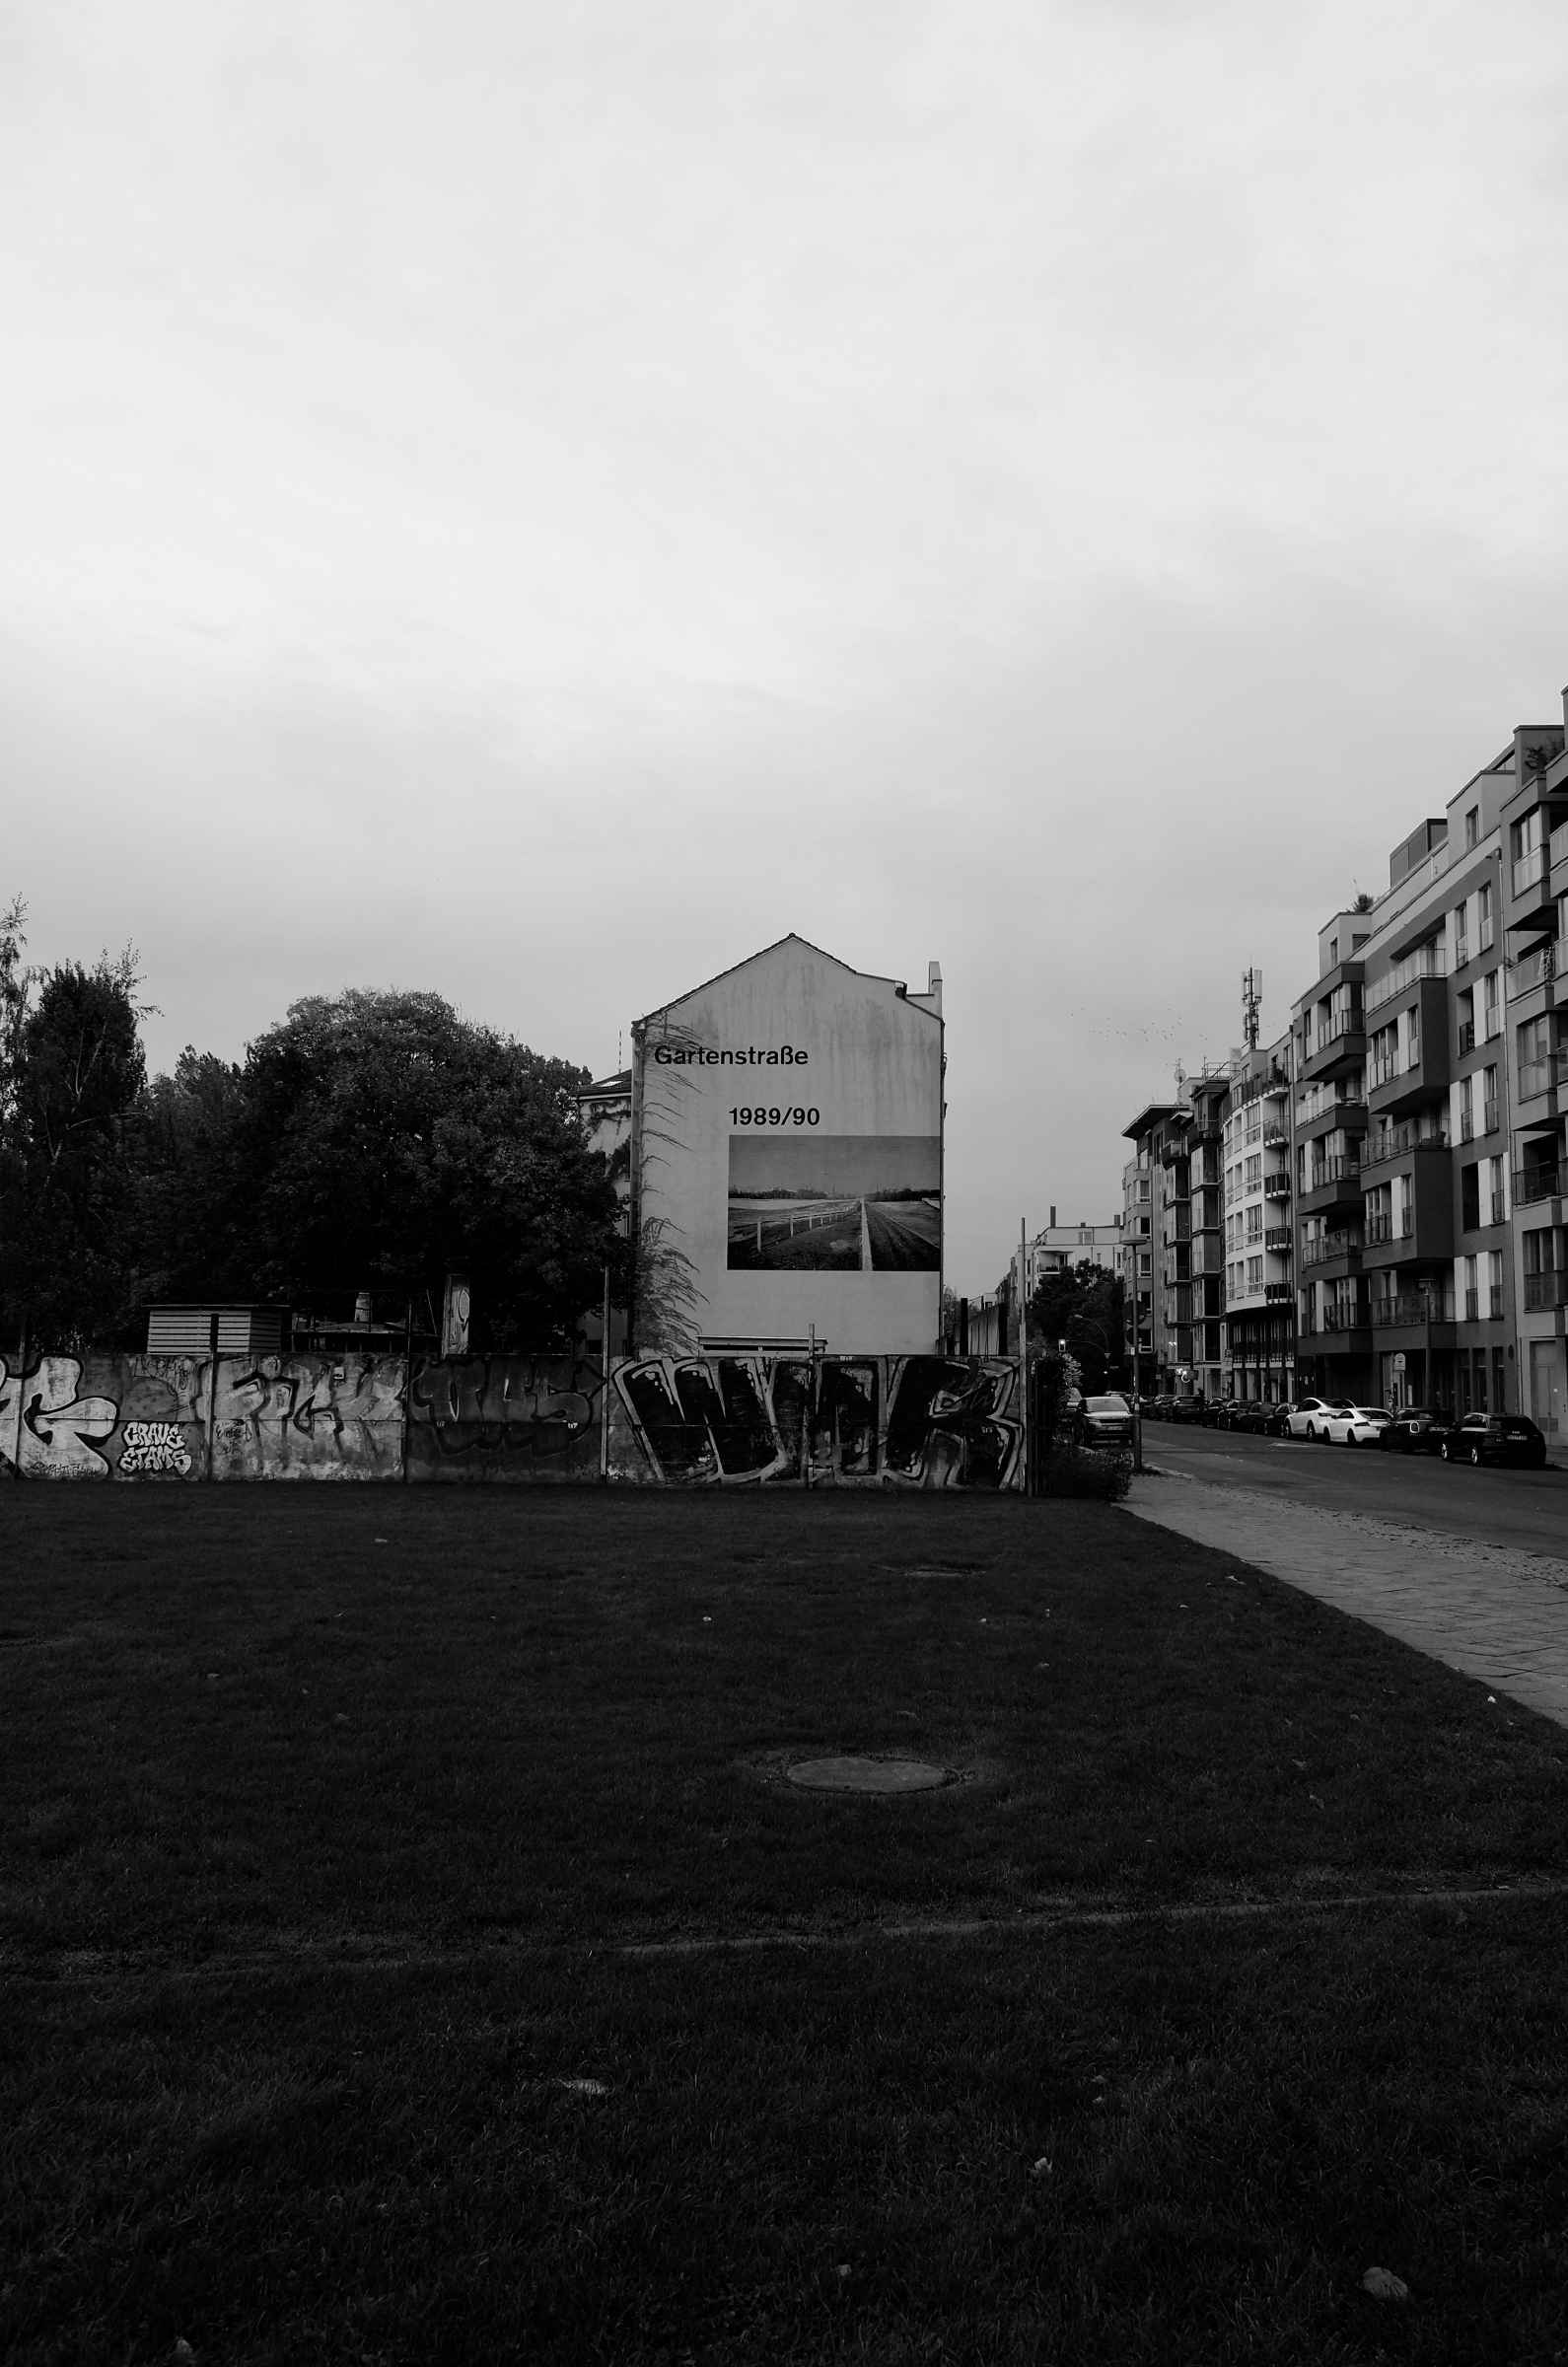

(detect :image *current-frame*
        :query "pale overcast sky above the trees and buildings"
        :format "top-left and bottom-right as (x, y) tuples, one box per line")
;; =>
(0, 0), (1568, 1292)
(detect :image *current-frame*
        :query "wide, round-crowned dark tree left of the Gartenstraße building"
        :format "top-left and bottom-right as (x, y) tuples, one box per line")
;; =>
(145, 989), (623, 1349)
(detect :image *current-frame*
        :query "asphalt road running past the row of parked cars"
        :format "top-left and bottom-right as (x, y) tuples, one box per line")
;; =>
(1144, 1422), (1568, 1560)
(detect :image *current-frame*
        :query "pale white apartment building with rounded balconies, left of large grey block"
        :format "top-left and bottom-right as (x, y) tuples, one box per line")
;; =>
(1215, 1035), (1296, 1406)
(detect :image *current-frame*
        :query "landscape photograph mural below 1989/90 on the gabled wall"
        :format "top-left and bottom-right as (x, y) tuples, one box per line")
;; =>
(727, 1134), (943, 1273)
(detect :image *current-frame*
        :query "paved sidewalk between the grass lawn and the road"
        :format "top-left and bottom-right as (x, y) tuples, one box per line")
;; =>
(1127, 1472), (1568, 1726)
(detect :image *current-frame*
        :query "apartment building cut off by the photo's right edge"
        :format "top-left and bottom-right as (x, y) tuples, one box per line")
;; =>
(1499, 691), (1568, 1439)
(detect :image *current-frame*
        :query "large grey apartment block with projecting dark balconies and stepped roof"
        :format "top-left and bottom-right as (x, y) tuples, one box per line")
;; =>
(1293, 748), (1519, 1413)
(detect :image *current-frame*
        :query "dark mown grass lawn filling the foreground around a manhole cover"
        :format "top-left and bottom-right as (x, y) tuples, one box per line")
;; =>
(0, 1486), (1568, 2367)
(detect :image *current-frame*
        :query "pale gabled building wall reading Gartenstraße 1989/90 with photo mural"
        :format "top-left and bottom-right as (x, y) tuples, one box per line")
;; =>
(630, 935), (945, 1356)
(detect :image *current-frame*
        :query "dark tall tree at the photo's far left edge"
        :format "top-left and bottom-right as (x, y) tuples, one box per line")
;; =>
(0, 904), (147, 1349)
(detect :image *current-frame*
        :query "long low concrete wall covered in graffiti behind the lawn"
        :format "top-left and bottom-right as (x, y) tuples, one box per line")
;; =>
(0, 1356), (1021, 1489)
